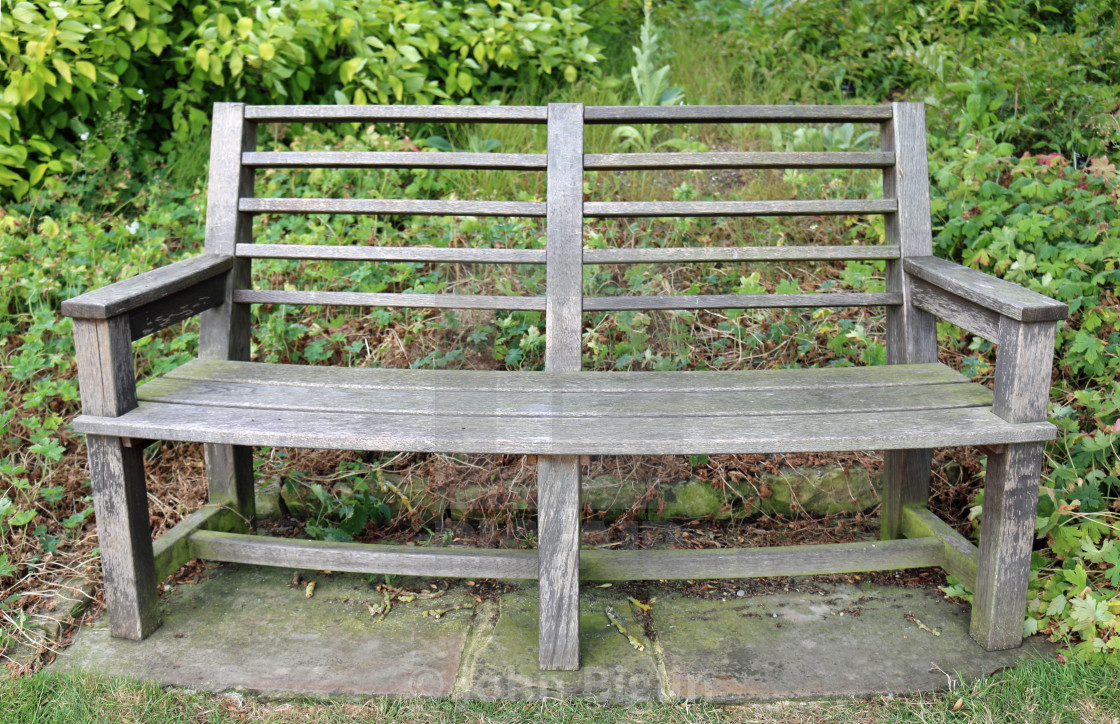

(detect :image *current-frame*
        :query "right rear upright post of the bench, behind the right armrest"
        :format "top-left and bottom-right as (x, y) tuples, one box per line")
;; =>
(880, 103), (937, 540)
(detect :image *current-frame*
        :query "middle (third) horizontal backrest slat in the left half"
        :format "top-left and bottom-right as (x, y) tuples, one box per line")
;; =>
(239, 198), (545, 217)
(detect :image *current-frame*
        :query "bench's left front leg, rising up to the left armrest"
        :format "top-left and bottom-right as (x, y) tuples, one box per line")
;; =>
(74, 315), (159, 641)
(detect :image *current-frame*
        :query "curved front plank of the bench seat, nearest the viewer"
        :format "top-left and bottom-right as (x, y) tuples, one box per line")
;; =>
(74, 402), (1055, 455)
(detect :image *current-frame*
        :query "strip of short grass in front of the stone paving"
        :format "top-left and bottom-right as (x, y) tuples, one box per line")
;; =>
(0, 660), (1120, 724)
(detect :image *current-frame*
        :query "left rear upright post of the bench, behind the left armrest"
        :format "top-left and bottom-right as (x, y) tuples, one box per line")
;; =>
(198, 103), (256, 521)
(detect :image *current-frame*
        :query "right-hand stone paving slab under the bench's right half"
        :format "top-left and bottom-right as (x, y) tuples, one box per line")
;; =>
(653, 584), (1054, 702)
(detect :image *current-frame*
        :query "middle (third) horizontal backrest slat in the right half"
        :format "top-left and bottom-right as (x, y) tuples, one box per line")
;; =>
(586, 198), (896, 219)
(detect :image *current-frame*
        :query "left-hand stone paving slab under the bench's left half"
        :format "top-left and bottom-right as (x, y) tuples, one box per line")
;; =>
(52, 565), (472, 696)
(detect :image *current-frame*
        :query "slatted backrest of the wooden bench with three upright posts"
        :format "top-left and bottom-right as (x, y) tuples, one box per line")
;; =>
(200, 103), (936, 371)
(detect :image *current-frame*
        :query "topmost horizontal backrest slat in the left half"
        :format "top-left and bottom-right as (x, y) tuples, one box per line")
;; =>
(245, 105), (548, 123)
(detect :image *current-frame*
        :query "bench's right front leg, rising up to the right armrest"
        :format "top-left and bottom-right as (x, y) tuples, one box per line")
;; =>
(969, 317), (1056, 651)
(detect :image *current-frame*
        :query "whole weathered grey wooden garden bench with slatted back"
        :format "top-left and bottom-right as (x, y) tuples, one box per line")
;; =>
(63, 103), (1066, 669)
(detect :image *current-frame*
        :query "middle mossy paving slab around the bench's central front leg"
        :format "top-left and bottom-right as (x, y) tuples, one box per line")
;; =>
(456, 583), (662, 702)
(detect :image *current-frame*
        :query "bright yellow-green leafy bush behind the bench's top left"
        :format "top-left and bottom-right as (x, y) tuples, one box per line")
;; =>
(0, 0), (603, 198)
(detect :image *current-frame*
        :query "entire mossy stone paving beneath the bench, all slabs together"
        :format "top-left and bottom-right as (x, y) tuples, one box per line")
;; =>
(50, 565), (1052, 702)
